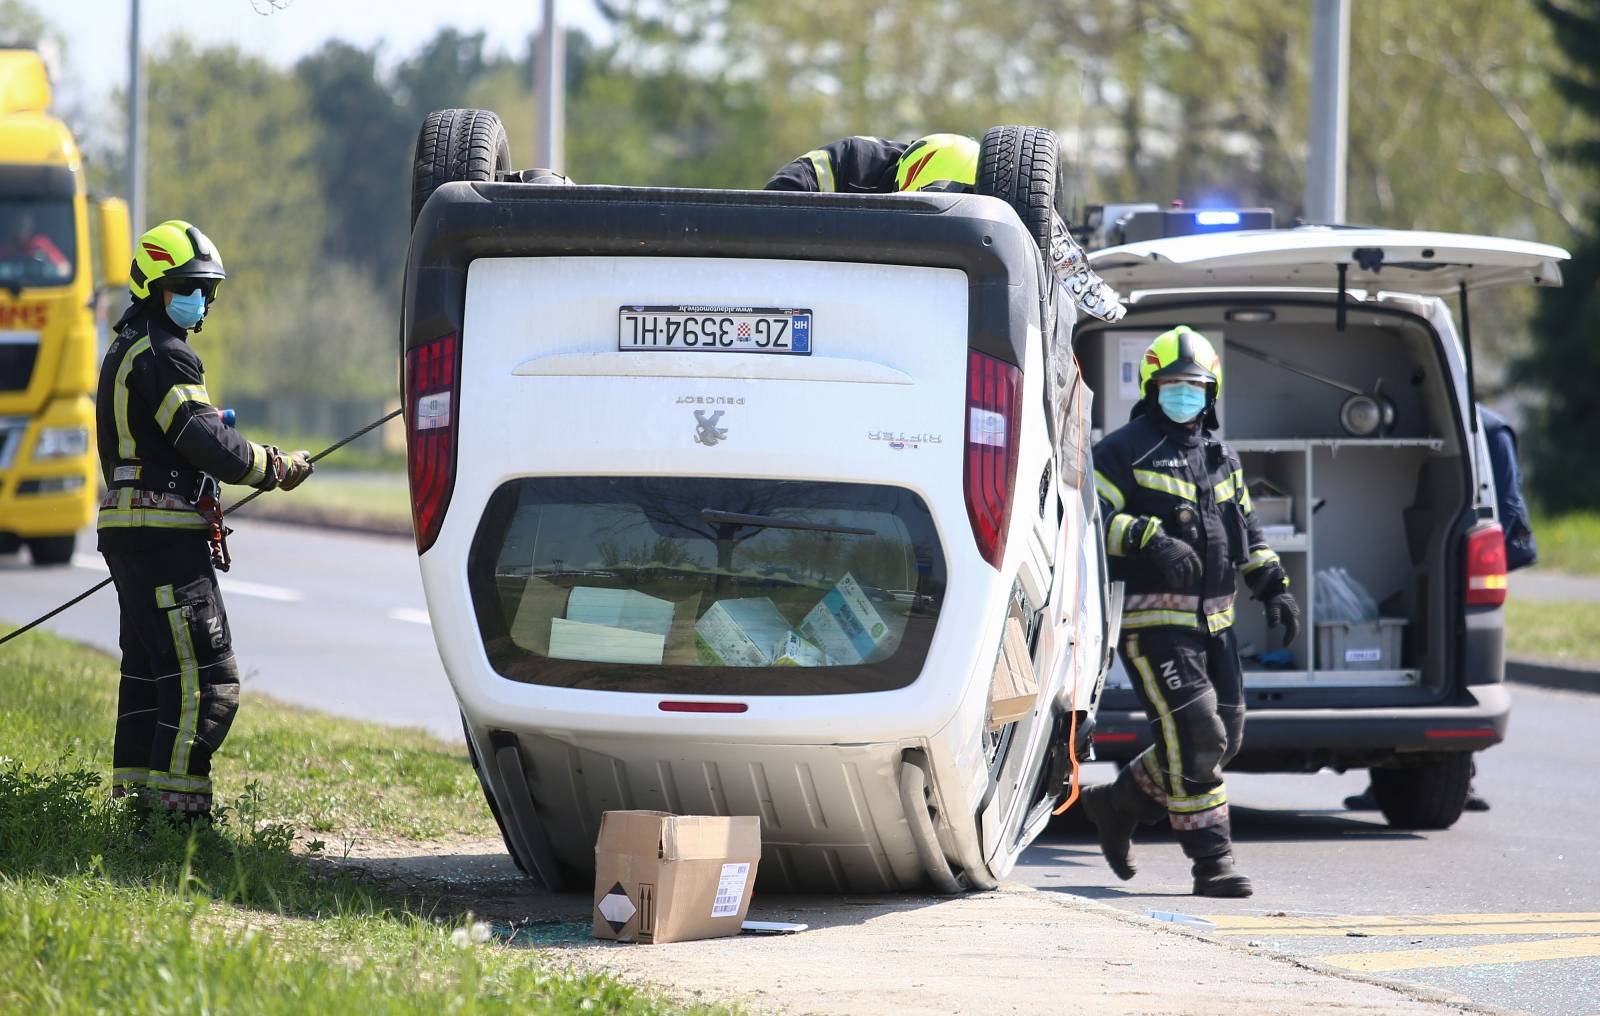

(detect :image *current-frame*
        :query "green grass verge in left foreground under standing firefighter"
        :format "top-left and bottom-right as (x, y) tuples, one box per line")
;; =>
(0, 634), (736, 1016)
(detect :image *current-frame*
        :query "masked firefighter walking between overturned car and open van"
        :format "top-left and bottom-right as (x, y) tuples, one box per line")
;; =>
(1083, 326), (1299, 896)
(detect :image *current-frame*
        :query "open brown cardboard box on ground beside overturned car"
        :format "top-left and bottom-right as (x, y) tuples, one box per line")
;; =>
(594, 811), (762, 944)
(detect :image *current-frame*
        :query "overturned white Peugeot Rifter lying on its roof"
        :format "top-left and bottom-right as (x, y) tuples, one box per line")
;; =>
(403, 110), (1115, 891)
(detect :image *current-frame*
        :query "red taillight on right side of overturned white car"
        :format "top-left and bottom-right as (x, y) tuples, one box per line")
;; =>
(965, 352), (1022, 568)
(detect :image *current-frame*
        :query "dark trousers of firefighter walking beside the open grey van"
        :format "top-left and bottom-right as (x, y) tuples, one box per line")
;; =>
(1117, 627), (1245, 859)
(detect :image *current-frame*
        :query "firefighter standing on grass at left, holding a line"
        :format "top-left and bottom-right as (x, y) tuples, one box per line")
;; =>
(96, 219), (312, 821)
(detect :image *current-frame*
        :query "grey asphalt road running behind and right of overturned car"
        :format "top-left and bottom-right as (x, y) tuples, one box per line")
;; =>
(0, 517), (1600, 1016)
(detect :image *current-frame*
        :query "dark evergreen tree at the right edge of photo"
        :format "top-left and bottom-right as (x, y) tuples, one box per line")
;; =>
(1520, 0), (1600, 510)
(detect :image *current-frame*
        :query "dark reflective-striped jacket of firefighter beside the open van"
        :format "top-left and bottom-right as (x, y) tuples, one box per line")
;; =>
(1094, 402), (1288, 632)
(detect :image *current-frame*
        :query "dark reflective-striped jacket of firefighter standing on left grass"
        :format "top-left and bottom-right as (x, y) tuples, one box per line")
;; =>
(94, 307), (277, 552)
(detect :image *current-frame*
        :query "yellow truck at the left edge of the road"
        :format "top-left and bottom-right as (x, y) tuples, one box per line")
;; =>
(0, 50), (130, 565)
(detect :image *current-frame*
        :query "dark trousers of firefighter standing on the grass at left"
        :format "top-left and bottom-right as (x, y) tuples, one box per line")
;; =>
(106, 539), (238, 813)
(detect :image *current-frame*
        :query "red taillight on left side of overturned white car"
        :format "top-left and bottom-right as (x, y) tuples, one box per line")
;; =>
(405, 334), (459, 554)
